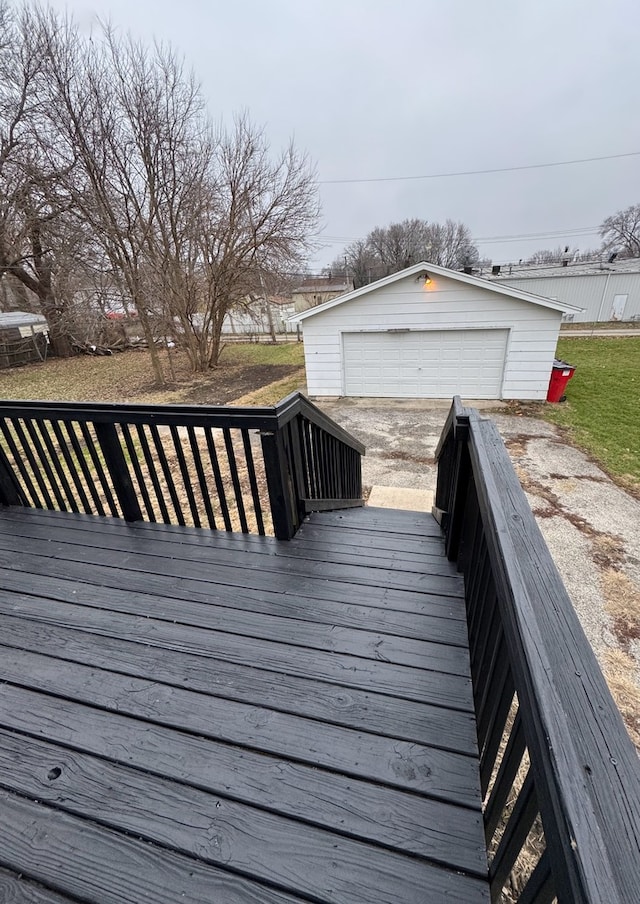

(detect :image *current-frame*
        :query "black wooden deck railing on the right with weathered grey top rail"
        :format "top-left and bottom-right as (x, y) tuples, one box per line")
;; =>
(436, 398), (640, 904)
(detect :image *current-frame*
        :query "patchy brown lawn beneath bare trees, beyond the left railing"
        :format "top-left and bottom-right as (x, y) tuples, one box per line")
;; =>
(0, 342), (305, 405)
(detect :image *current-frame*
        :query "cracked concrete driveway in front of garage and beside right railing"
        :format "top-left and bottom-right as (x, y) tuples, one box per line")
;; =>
(320, 399), (640, 747)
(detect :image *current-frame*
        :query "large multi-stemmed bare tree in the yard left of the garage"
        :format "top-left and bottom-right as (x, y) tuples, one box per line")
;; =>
(33, 11), (318, 381)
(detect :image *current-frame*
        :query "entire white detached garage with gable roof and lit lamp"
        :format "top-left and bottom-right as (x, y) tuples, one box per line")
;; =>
(294, 263), (578, 399)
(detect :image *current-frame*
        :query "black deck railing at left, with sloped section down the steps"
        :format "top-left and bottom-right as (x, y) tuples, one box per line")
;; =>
(0, 393), (364, 539)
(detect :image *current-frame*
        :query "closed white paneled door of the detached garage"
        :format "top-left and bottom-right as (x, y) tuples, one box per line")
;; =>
(342, 330), (509, 399)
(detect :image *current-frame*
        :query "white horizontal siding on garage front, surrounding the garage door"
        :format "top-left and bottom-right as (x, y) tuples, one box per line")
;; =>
(303, 276), (561, 399)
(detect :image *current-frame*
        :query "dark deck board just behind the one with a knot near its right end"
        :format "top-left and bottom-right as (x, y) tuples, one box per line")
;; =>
(0, 618), (476, 756)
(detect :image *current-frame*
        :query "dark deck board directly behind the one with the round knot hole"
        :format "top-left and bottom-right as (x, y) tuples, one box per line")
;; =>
(0, 686), (483, 871)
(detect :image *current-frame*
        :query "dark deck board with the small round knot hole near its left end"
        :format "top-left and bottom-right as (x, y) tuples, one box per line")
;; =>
(0, 734), (490, 904)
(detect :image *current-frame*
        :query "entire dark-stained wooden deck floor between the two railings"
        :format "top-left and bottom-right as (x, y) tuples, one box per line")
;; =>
(0, 508), (489, 904)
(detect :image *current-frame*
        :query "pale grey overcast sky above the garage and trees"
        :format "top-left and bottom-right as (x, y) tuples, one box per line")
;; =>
(48, 0), (640, 269)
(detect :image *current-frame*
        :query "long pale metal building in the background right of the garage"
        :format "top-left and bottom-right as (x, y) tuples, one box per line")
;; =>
(482, 258), (640, 323)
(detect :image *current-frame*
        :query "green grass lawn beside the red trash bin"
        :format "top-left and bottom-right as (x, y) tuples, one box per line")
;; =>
(542, 336), (640, 490)
